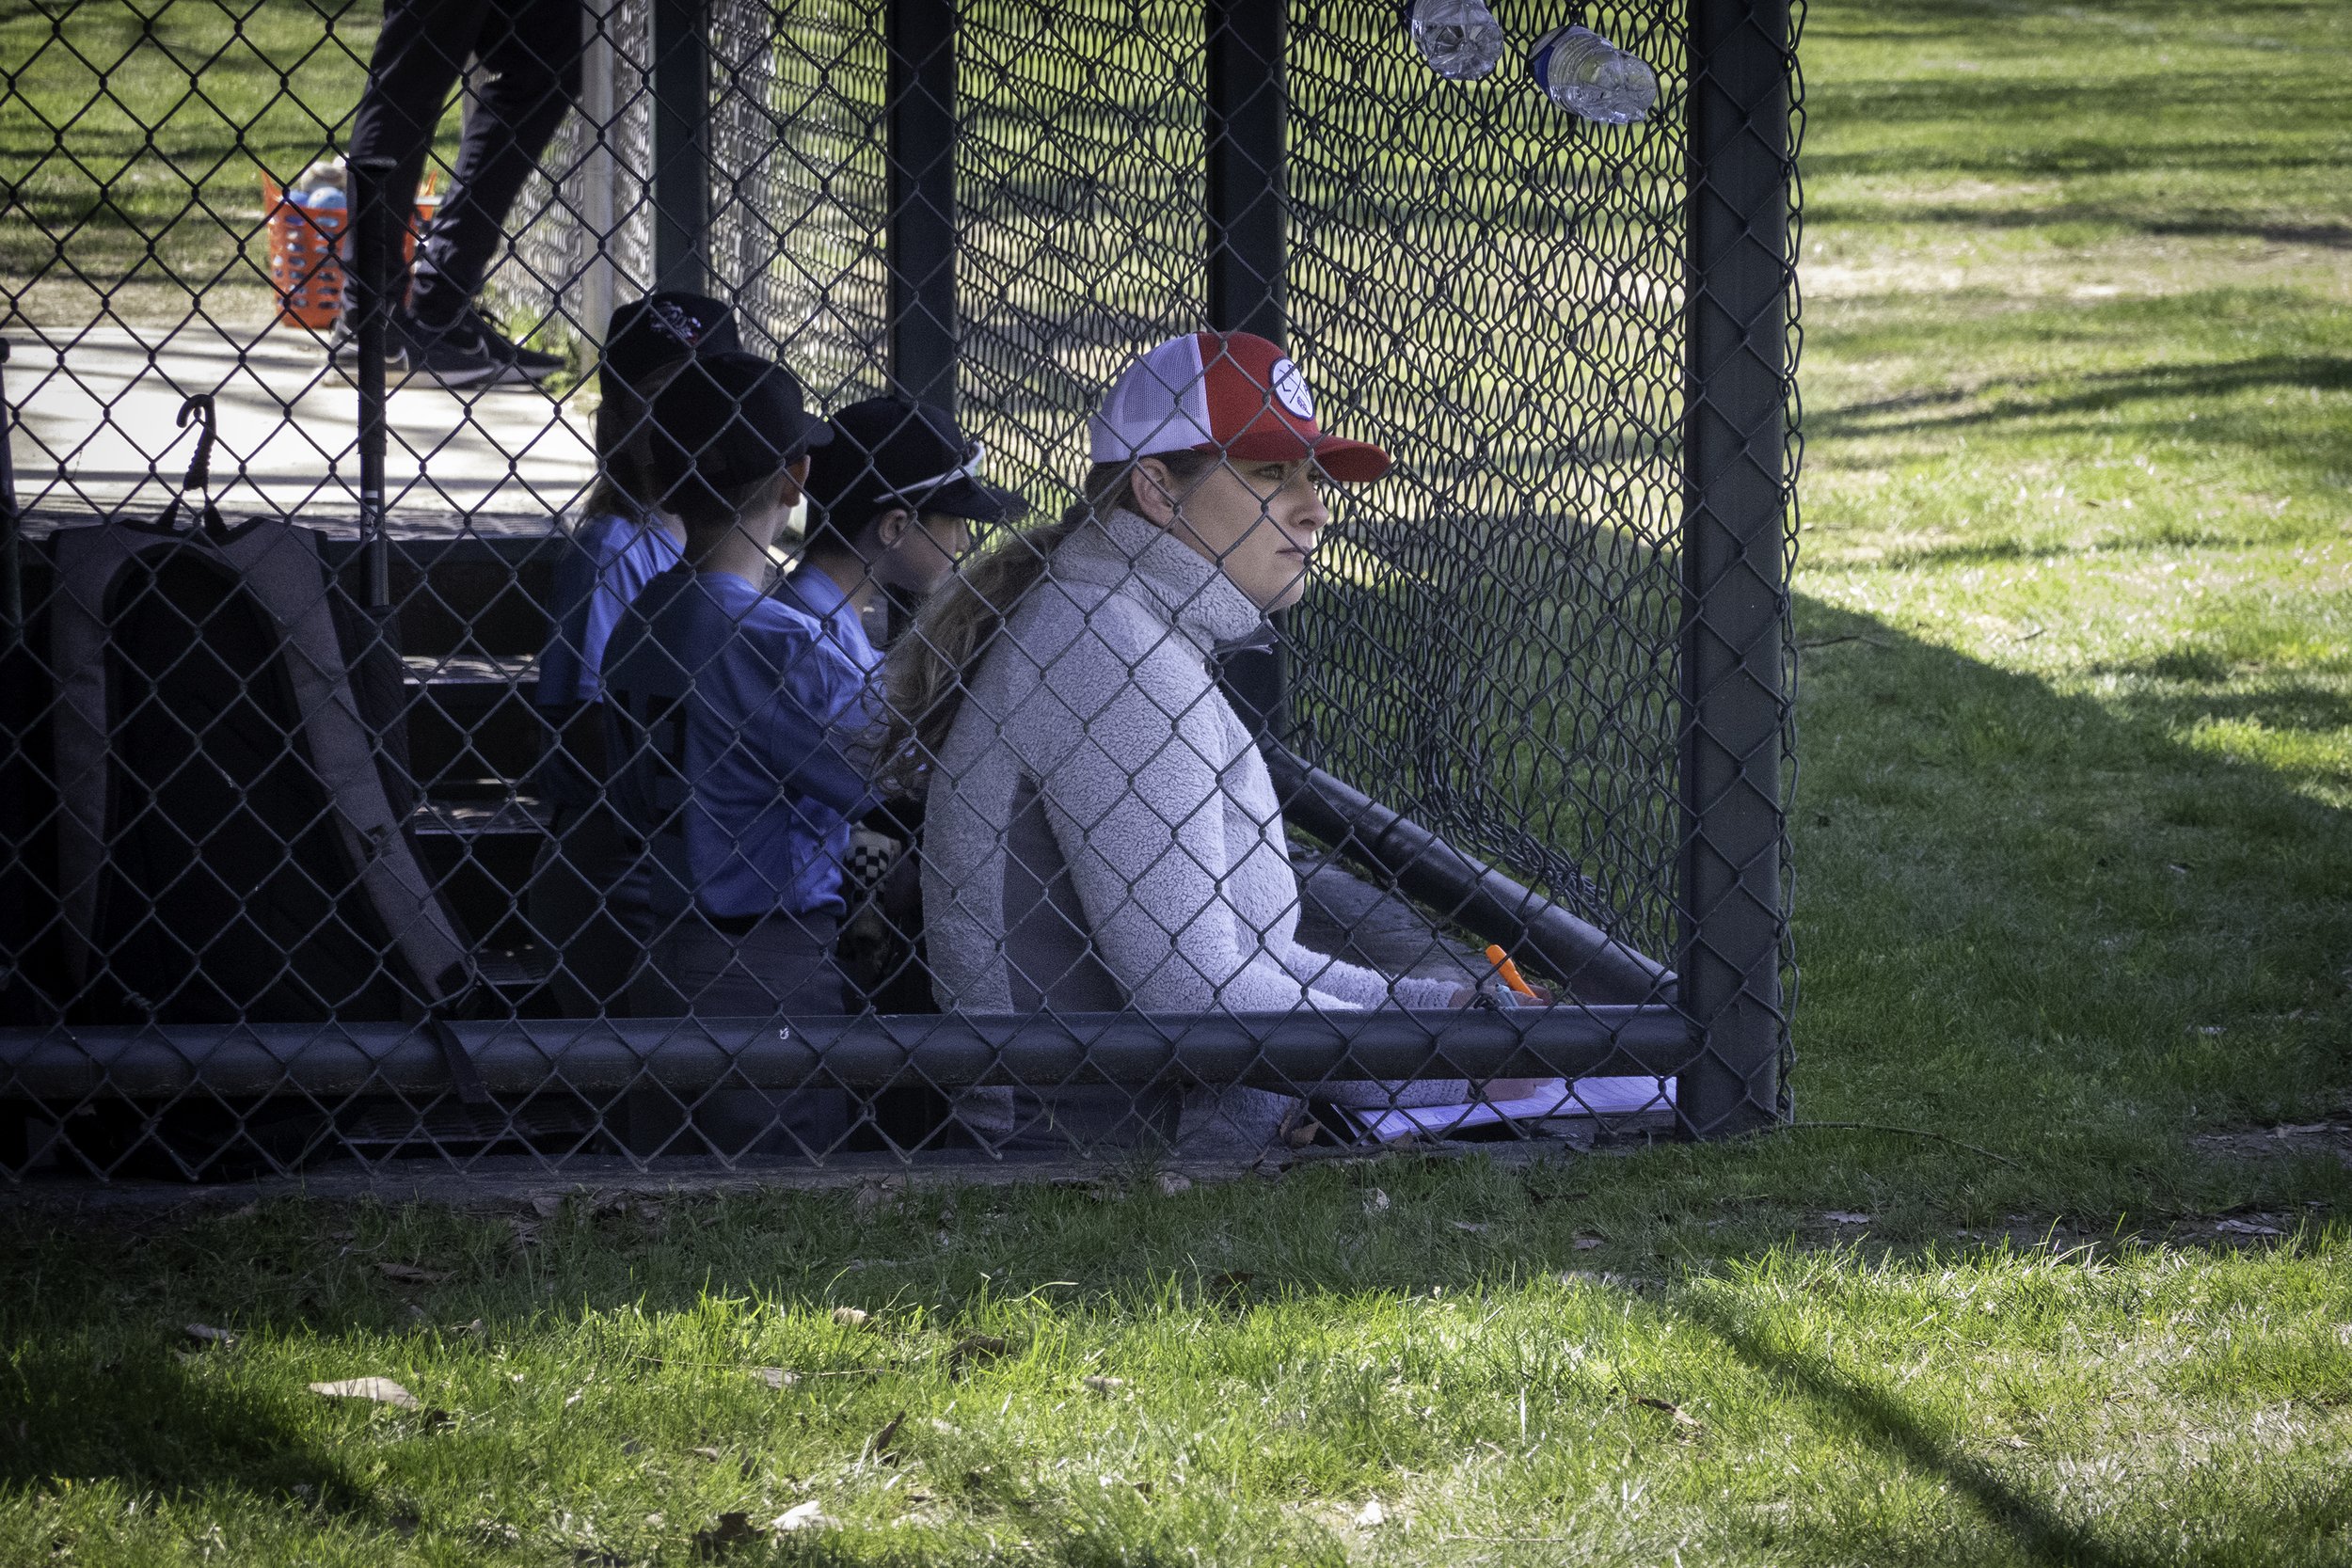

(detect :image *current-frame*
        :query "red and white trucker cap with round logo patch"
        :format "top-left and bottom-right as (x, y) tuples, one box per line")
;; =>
(1087, 331), (1388, 484)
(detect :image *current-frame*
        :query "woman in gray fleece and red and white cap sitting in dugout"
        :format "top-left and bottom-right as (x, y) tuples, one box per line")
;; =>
(884, 331), (1524, 1152)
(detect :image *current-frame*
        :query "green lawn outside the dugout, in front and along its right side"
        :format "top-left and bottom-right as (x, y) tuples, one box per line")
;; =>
(0, 0), (2352, 1568)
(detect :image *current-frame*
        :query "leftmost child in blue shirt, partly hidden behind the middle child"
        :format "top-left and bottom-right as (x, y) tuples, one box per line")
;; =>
(525, 292), (739, 1016)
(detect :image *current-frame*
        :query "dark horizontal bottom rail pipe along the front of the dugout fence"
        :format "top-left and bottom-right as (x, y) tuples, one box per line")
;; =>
(0, 1004), (1703, 1102)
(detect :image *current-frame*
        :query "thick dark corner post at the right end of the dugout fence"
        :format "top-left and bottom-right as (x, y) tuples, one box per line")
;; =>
(1677, 0), (1790, 1135)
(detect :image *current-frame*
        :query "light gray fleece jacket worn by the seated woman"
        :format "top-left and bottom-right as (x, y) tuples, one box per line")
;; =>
(922, 513), (1454, 1148)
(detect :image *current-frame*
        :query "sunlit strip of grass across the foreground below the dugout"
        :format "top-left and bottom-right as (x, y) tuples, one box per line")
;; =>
(0, 1180), (2352, 1563)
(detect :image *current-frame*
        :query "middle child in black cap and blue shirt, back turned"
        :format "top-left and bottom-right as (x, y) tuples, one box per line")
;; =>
(602, 342), (875, 1154)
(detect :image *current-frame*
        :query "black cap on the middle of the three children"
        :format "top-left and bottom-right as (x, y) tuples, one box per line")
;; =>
(652, 350), (833, 510)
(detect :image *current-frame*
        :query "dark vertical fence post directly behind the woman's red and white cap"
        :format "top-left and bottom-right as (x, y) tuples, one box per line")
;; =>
(1204, 0), (1289, 736)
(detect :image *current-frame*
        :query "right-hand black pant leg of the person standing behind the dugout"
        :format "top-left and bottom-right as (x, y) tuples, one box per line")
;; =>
(409, 0), (583, 326)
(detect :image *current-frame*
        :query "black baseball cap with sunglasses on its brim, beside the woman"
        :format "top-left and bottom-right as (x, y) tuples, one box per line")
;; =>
(809, 397), (1028, 529)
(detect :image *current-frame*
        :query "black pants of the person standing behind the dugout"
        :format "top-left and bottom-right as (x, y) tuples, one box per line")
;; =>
(351, 0), (583, 322)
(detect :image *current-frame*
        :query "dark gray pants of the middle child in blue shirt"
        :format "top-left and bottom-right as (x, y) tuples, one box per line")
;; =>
(628, 912), (850, 1159)
